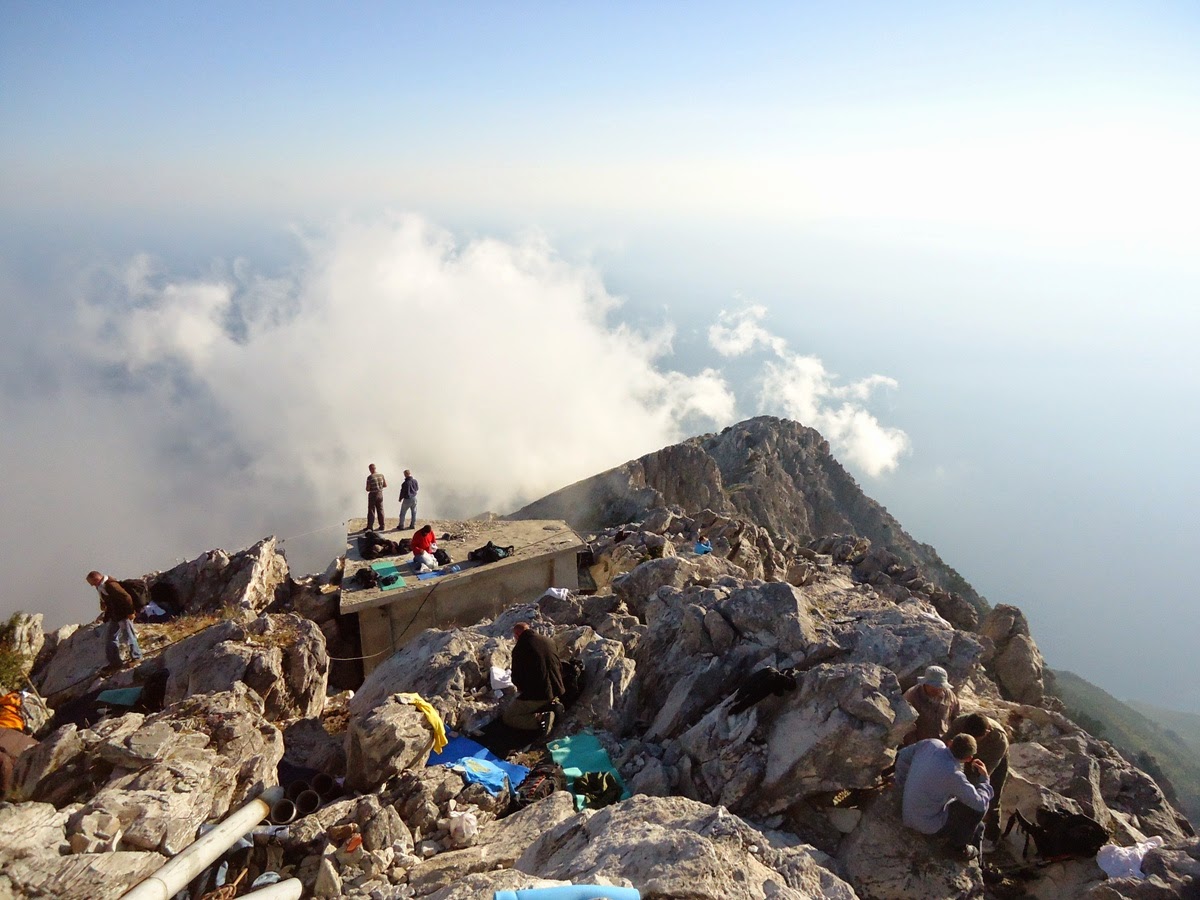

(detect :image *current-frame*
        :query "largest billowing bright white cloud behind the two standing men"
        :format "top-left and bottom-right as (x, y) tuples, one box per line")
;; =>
(72, 216), (733, 535)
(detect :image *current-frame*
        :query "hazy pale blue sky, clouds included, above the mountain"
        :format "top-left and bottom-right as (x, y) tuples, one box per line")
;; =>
(0, 2), (1200, 710)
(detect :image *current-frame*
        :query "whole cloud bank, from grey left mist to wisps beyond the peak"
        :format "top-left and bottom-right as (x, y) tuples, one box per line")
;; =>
(2, 215), (908, 619)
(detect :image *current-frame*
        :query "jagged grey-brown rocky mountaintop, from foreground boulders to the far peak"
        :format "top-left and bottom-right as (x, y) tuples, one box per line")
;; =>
(0, 419), (1200, 900)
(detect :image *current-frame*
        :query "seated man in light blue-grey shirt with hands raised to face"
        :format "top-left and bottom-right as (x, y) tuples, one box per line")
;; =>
(896, 734), (992, 860)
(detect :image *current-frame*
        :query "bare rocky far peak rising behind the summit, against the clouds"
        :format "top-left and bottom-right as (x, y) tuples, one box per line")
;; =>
(512, 416), (988, 613)
